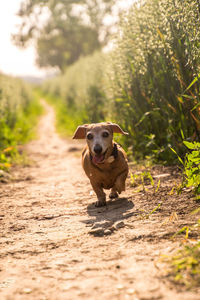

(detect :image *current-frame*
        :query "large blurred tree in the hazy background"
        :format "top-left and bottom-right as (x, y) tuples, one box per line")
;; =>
(13, 0), (116, 71)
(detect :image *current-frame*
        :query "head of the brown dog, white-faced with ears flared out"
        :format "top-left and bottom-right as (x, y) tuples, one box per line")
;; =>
(73, 122), (128, 164)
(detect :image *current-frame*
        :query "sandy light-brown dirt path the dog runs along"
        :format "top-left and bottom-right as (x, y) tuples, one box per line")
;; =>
(0, 104), (200, 300)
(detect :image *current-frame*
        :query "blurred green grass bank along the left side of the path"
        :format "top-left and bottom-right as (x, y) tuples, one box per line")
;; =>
(0, 74), (42, 169)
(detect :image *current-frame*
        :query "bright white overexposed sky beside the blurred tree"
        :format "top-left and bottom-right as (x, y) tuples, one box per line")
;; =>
(0, 0), (134, 77)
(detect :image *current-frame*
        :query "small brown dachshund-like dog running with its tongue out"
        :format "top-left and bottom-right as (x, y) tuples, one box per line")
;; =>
(73, 122), (128, 207)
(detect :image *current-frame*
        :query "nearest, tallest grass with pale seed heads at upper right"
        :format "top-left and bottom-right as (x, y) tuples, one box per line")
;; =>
(109, 0), (200, 162)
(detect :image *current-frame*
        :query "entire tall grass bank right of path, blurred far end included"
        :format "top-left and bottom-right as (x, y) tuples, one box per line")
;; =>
(42, 0), (200, 163)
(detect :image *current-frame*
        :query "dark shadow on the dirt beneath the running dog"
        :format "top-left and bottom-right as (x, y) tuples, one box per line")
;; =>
(82, 198), (136, 236)
